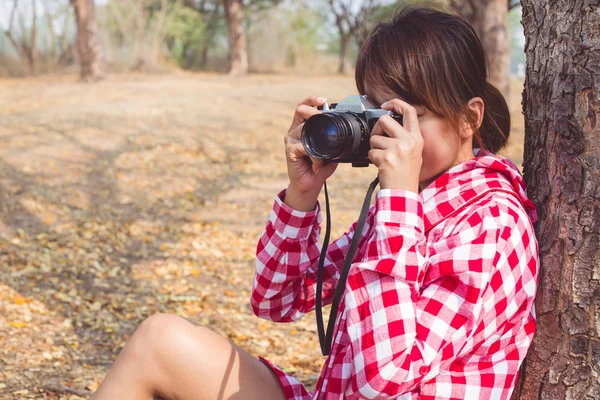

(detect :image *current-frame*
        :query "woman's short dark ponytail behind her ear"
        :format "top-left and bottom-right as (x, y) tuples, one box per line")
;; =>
(473, 82), (510, 153)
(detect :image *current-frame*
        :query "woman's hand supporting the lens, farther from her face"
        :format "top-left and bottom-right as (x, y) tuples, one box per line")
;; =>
(284, 96), (337, 211)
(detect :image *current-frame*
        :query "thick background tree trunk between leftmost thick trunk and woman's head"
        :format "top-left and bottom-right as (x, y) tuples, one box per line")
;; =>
(225, 0), (248, 75)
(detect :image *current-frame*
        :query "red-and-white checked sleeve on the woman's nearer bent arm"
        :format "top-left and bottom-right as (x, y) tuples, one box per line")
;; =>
(344, 190), (510, 399)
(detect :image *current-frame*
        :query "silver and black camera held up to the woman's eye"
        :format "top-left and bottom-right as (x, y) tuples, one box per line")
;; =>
(302, 95), (402, 167)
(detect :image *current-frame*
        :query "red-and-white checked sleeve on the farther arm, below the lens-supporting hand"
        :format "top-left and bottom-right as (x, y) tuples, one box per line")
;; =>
(250, 190), (372, 322)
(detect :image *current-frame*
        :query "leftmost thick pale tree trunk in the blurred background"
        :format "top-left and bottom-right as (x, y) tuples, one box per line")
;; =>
(71, 0), (106, 81)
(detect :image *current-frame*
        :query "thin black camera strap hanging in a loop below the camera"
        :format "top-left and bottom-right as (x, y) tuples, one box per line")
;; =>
(315, 177), (379, 356)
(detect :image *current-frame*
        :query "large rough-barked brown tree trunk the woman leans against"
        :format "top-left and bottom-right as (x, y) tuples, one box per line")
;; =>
(515, 0), (600, 400)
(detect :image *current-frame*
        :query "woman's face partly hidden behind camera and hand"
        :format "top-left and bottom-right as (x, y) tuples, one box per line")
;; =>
(365, 85), (474, 189)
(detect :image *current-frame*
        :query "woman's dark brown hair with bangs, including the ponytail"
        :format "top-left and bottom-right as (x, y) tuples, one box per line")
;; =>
(355, 4), (510, 153)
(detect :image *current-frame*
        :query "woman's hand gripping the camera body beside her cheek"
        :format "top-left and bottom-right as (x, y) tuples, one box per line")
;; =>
(369, 99), (423, 193)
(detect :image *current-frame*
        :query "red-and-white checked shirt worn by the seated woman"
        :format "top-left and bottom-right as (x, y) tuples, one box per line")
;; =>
(251, 153), (538, 400)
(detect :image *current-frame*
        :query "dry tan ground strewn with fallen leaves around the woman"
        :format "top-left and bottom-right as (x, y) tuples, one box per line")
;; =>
(0, 74), (523, 399)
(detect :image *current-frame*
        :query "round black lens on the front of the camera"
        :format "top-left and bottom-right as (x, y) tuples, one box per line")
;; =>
(302, 113), (364, 159)
